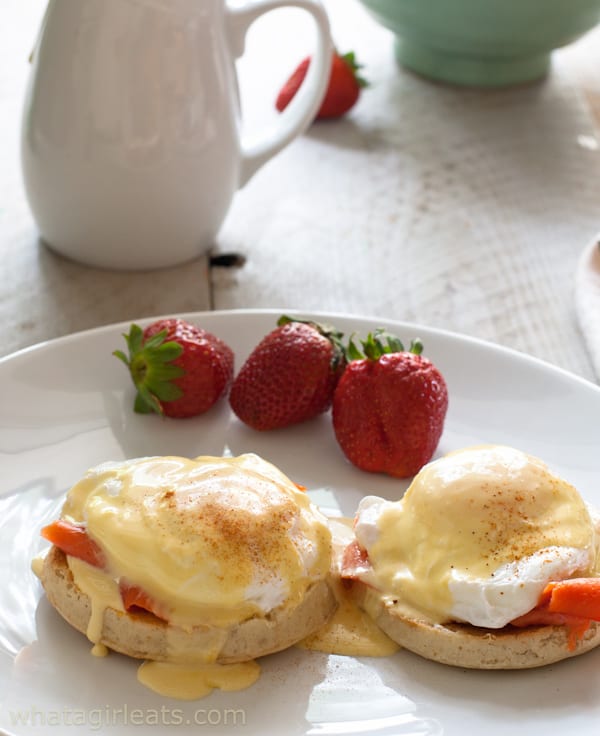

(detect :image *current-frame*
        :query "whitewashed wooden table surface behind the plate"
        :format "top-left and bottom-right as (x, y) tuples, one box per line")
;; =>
(0, 0), (600, 381)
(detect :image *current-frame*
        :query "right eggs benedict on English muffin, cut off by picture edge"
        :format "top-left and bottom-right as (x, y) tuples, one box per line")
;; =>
(343, 446), (600, 669)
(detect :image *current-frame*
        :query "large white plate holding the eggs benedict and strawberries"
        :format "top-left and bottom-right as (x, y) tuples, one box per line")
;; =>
(0, 311), (600, 736)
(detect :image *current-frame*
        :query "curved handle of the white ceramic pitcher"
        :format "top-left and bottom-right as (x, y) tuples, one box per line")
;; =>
(226, 0), (333, 187)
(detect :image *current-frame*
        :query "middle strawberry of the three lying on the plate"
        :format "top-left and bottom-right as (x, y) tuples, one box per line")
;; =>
(229, 316), (346, 430)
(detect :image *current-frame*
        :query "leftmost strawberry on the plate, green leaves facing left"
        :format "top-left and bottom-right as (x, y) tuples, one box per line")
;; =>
(113, 318), (233, 417)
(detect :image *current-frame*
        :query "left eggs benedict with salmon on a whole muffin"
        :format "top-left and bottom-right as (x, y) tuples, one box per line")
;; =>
(39, 454), (336, 696)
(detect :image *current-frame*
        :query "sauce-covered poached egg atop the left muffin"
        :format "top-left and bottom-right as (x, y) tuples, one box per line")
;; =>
(62, 454), (331, 629)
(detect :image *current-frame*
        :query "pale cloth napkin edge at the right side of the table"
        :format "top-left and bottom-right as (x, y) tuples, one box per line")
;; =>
(575, 235), (600, 380)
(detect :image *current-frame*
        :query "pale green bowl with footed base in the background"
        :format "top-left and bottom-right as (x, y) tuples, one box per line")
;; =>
(360, 0), (600, 87)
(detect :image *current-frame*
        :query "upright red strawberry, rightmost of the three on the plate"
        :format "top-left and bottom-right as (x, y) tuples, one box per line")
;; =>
(332, 329), (448, 478)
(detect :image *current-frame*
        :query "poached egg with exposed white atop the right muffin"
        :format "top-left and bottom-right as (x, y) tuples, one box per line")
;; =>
(354, 445), (597, 629)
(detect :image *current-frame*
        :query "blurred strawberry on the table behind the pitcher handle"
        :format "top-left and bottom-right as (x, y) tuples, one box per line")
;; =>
(275, 51), (367, 119)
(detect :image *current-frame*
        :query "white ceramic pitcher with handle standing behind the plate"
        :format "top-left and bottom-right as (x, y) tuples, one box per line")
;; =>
(22, 0), (331, 270)
